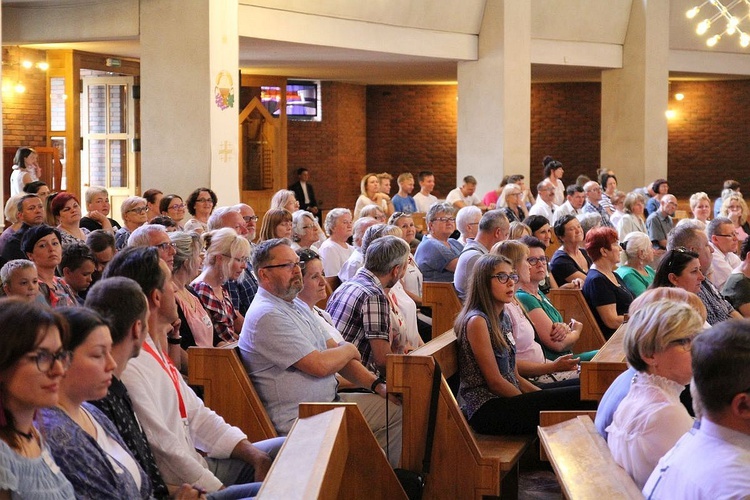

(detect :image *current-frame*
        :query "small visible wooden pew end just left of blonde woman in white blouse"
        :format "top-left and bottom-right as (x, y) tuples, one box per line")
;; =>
(580, 323), (628, 401)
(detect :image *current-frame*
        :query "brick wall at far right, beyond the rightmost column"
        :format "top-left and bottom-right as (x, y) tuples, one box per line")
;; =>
(668, 80), (750, 198)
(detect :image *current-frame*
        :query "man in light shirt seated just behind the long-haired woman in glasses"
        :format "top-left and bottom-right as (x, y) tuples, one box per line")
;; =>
(453, 210), (510, 302)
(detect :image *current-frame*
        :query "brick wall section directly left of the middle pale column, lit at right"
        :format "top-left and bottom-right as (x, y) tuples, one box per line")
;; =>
(367, 85), (458, 197)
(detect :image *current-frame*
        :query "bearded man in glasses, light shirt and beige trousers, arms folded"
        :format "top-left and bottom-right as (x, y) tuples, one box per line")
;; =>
(239, 237), (408, 467)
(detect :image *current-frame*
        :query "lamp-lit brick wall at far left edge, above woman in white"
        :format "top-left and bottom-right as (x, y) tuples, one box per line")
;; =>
(2, 47), (47, 148)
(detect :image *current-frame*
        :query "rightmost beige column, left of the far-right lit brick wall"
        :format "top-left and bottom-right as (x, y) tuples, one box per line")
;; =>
(601, 0), (669, 191)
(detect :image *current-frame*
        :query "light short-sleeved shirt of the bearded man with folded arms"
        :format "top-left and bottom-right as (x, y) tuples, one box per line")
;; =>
(239, 288), (337, 434)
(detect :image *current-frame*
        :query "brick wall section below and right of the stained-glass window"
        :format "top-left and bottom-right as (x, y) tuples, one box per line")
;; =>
(287, 82), (366, 209)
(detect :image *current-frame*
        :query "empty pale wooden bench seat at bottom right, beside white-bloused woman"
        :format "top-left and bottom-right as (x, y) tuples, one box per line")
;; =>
(539, 416), (643, 499)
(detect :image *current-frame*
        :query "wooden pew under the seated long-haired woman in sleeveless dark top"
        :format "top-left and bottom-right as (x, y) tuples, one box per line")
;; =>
(386, 330), (534, 499)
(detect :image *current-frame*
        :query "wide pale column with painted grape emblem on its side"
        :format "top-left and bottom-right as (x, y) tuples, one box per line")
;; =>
(140, 0), (240, 205)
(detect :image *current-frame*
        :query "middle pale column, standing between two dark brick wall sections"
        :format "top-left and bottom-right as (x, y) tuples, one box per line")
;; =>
(456, 0), (531, 196)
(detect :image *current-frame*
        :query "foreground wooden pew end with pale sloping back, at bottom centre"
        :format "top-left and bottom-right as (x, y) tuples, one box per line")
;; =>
(258, 403), (406, 500)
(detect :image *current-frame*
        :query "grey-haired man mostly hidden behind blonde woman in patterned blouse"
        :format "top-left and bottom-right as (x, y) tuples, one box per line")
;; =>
(208, 203), (258, 315)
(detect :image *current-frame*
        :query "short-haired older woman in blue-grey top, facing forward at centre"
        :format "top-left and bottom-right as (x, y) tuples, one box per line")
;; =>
(414, 202), (463, 283)
